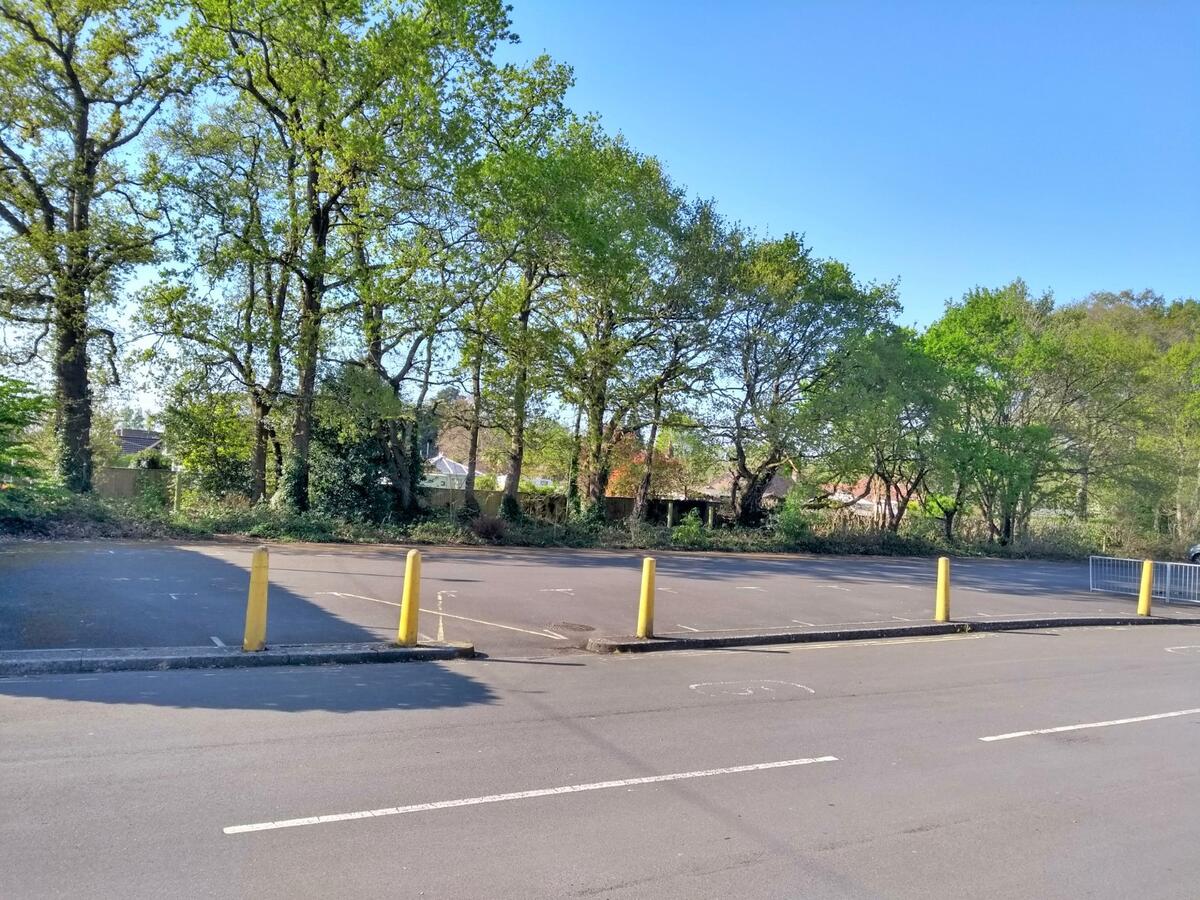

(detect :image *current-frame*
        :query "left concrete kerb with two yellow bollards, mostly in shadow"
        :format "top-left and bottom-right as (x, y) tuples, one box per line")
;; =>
(0, 642), (475, 676)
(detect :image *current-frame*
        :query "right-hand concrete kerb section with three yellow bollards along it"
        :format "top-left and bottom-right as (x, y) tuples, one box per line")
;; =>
(587, 616), (1200, 653)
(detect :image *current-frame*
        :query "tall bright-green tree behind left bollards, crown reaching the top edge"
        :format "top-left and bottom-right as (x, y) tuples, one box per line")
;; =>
(187, 0), (508, 510)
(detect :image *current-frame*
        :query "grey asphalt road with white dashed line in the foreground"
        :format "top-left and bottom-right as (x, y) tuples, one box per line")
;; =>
(0, 625), (1200, 900)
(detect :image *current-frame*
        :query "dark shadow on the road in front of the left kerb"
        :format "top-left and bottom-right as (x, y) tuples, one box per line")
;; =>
(0, 662), (497, 713)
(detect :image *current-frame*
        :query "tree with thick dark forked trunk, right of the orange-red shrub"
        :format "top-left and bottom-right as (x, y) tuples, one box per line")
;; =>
(708, 235), (896, 526)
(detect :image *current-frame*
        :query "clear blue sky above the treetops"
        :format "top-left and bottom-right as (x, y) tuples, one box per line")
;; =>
(496, 0), (1200, 324)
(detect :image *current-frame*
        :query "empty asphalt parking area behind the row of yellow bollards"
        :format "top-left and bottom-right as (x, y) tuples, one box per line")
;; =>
(0, 541), (1192, 655)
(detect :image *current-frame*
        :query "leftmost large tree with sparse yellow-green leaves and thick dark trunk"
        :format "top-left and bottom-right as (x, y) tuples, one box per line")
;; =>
(0, 0), (187, 492)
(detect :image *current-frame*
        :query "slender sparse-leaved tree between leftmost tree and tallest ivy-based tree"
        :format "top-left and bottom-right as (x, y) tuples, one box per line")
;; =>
(140, 110), (300, 502)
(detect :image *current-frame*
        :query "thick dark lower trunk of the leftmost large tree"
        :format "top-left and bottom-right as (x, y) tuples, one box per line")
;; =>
(54, 288), (92, 493)
